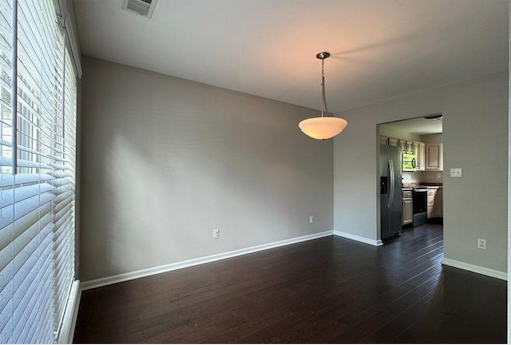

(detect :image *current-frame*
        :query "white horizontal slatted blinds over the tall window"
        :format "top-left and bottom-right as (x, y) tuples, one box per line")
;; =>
(0, 0), (76, 343)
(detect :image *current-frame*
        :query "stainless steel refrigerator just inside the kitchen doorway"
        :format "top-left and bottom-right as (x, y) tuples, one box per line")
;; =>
(380, 145), (403, 239)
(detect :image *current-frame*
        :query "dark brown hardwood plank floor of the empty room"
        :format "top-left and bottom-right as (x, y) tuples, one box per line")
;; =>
(74, 224), (507, 343)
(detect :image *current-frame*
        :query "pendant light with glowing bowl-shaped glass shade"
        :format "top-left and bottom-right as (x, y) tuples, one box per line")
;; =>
(298, 52), (348, 140)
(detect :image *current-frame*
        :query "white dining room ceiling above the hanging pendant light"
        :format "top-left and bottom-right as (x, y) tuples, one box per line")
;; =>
(74, 0), (509, 112)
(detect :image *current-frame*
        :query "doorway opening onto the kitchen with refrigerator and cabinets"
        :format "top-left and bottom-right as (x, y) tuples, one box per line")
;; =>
(377, 114), (443, 245)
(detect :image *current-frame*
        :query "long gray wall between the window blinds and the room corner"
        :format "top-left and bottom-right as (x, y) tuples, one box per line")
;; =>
(80, 57), (333, 281)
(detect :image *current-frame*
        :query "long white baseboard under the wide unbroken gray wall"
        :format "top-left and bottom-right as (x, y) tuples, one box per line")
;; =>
(81, 230), (334, 291)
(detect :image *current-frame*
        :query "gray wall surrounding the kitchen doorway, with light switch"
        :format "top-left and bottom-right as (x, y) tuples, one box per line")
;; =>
(334, 73), (508, 272)
